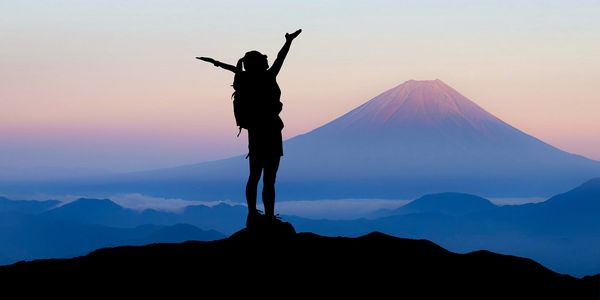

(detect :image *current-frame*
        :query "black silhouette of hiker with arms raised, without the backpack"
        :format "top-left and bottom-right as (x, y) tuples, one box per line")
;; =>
(197, 29), (302, 227)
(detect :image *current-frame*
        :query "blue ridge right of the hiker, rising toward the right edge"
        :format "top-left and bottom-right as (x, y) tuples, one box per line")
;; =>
(288, 178), (600, 276)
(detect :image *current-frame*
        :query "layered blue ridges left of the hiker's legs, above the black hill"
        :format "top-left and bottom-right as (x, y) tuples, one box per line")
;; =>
(0, 198), (230, 265)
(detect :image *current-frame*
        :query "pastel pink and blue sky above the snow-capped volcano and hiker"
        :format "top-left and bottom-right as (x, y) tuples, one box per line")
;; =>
(0, 0), (600, 175)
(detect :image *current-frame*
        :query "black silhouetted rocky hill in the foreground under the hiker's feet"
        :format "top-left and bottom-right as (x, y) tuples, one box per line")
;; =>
(0, 229), (600, 299)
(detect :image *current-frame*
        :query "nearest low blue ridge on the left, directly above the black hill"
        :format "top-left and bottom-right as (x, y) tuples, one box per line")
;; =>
(0, 212), (224, 265)
